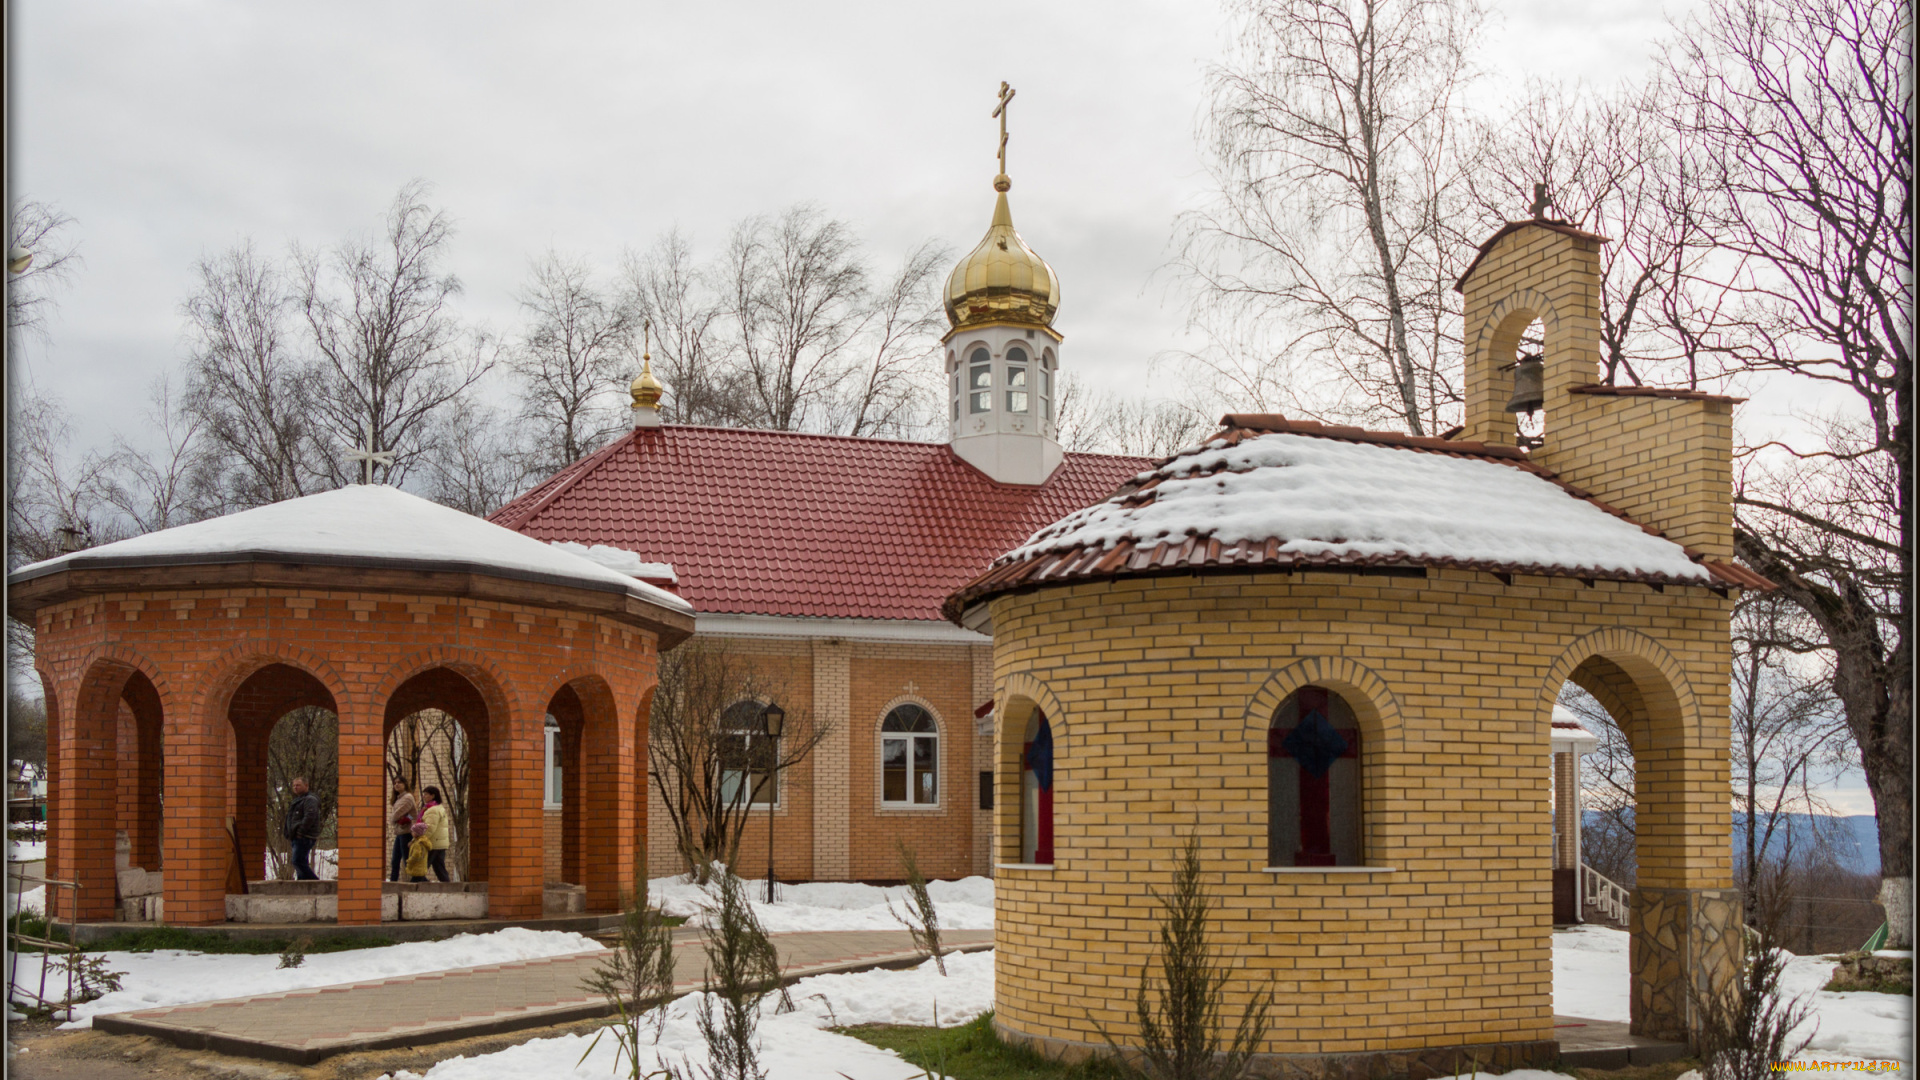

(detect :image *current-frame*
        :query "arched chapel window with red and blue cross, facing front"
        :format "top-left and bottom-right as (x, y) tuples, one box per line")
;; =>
(1267, 686), (1361, 867)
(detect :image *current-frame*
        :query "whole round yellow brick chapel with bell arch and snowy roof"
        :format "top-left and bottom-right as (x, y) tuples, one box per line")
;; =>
(945, 219), (1766, 1076)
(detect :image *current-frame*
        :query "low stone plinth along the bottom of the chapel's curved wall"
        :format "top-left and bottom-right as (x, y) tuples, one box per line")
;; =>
(993, 1019), (1559, 1080)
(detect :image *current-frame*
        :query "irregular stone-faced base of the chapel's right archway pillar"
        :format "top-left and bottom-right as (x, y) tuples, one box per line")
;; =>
(1628, 886), (1747, 1043)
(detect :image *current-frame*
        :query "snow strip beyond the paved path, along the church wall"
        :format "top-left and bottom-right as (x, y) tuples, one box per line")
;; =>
(647, 874), (993, 934)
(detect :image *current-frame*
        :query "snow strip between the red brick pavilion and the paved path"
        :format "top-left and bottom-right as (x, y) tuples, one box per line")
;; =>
(7, 928), (605, 1028)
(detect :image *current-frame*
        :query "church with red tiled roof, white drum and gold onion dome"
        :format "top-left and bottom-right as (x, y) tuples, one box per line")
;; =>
(493, 147), (1152, 882)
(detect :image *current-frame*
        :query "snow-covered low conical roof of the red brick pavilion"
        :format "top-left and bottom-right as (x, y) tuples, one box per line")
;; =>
(8, 484), (693, 613)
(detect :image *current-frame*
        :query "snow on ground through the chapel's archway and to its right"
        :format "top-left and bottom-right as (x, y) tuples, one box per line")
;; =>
(1559, 926), (1914, 1076)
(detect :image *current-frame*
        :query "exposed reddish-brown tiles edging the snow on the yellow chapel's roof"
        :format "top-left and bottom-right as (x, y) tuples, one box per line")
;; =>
(943, 413), (1774, 623)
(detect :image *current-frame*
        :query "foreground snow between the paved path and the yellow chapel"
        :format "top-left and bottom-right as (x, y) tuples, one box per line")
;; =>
(382, 951), (993, 1080)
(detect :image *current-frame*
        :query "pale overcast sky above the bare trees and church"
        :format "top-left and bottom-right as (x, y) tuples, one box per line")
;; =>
(8, 0), (1686, 442)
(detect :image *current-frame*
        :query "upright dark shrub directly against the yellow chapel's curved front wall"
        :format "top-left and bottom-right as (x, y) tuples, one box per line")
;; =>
(1100, 836), (1273, 1080)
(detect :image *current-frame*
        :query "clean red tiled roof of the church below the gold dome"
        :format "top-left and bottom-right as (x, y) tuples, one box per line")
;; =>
(493, 427), (1152, 621)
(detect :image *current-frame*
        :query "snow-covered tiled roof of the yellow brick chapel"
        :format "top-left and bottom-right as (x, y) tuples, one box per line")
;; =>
(947, 415), (1764, 619)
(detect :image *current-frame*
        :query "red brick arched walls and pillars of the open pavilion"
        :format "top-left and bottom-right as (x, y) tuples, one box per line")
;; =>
(35, 588), (655, 922)
